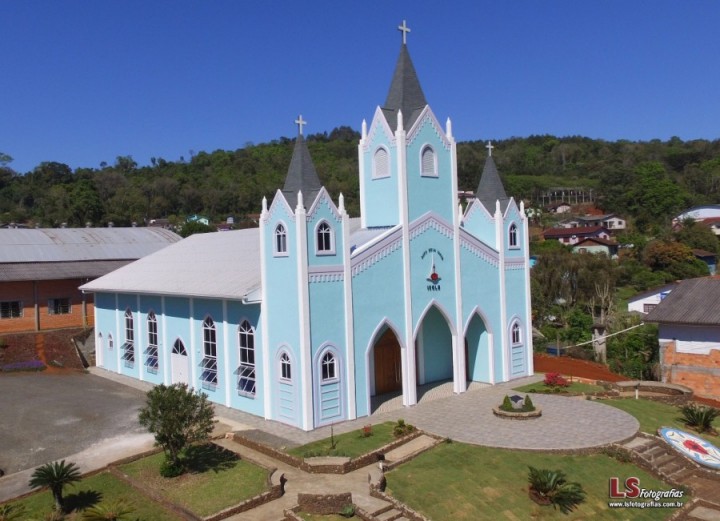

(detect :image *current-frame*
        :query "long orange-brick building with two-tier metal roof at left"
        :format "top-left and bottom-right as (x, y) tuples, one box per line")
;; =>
(0, 228), (180, 334)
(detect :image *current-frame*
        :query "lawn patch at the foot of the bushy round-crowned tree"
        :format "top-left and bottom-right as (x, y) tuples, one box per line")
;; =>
(120, 444), (268, 517)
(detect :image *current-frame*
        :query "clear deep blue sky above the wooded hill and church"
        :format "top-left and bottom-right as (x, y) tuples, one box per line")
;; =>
(0, 0), (720, 173)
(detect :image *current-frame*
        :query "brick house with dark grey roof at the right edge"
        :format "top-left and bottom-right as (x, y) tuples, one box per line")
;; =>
(645, 277), (720, 400)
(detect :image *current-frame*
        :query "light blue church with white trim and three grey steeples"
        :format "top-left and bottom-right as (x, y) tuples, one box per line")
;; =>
(81, 22), (533, 430)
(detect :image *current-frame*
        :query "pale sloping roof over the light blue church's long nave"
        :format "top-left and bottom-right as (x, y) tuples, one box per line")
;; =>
(80, 228), (260, 300)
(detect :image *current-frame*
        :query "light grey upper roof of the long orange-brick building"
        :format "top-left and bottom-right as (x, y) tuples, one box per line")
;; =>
(0, 228), (180, 264)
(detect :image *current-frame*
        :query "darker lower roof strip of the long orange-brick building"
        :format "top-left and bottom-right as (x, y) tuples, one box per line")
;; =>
(0, 260), (132, 282)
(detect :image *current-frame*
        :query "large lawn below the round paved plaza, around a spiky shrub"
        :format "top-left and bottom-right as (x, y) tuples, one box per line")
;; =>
(387, 443), (689, 521)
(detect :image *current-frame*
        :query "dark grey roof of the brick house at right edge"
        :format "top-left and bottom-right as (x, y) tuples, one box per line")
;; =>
(645, 277), (720, 326)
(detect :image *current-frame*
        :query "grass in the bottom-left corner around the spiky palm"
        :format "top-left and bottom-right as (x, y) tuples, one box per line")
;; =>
(6, 472), (181, 521)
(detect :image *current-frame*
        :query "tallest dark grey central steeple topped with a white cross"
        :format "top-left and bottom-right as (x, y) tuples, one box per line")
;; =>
(382, 20), (427, 129)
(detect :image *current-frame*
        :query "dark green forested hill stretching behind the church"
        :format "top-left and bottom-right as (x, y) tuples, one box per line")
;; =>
(0, 127), (720, 229)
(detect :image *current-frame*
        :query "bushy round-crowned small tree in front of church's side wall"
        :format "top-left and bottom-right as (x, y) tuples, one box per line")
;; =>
(139, 384), (215, 475)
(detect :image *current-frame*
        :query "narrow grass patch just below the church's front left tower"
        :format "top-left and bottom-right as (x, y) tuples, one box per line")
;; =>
(287, 422), (395, 458)
